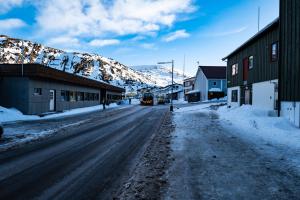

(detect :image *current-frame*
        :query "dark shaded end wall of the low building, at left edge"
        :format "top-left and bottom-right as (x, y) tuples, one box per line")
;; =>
(0, 77), (29, 113)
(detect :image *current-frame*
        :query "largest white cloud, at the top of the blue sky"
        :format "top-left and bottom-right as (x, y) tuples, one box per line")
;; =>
(36, 0), (193, 37)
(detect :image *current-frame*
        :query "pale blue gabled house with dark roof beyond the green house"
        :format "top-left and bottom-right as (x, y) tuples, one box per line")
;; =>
(193, 66), (227, 101)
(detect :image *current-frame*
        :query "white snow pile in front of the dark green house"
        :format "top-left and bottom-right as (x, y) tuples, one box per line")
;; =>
(217, 105), (300, 149)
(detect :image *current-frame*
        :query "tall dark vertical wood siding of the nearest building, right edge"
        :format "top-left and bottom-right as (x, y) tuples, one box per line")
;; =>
(279, 0), (300, 101)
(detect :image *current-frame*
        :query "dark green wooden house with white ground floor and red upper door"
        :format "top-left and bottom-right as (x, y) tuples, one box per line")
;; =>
(223, 19), (279, 111)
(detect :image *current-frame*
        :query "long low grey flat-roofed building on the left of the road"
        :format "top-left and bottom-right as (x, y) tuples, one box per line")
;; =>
(0, 64), (125, 115)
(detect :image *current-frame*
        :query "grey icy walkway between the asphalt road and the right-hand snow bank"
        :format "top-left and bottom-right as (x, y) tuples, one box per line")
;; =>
(165, 105), (300, 200)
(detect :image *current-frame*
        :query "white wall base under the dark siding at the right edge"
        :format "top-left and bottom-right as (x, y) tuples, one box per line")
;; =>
(280, 101), (300, 128)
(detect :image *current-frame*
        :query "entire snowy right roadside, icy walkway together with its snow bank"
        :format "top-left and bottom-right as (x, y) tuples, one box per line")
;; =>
(164, 103), (300, 199)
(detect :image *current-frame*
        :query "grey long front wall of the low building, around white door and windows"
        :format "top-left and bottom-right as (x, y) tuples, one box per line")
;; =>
(26, 79), (100, 114)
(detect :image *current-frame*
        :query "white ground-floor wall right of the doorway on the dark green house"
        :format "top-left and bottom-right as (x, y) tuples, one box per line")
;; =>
(252, 80), (278, 110)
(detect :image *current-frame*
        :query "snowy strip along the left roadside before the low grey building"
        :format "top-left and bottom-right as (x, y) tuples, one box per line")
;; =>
(0, 103), (134, 151)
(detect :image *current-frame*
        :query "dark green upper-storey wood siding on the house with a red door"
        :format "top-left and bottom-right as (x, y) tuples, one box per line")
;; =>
(227, 22), (279, 87)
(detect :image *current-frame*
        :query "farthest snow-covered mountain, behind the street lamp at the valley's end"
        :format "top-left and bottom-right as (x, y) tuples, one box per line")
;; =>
(130, 65), (187, 87)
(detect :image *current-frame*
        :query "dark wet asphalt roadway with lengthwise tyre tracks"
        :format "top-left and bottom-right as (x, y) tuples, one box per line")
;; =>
(0, 106), (168, 199)
